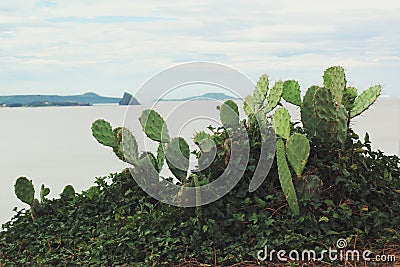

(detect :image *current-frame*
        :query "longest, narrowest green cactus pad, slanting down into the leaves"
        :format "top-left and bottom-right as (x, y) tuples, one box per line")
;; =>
(276, 139), (300, 215)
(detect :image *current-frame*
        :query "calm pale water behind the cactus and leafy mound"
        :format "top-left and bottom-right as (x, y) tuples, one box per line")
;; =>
(0, 98), (400, 224)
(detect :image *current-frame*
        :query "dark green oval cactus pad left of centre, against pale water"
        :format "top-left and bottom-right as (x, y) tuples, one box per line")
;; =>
(165, 137), (190, 181)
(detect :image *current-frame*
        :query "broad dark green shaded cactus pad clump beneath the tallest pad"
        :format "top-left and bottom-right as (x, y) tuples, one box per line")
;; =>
(301, 86), (348, 147)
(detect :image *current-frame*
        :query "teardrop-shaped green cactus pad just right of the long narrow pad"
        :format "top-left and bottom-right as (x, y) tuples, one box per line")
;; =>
(286, 133), (310, 178)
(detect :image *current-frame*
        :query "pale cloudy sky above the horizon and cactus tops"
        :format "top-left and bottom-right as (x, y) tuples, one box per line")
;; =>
(0, 0), (400, 97)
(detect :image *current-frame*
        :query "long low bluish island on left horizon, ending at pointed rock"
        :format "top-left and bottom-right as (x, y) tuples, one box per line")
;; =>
(0, 92), (140, 107)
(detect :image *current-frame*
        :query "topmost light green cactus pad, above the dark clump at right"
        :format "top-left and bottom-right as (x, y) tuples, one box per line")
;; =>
(323, 66), (347, 105)
